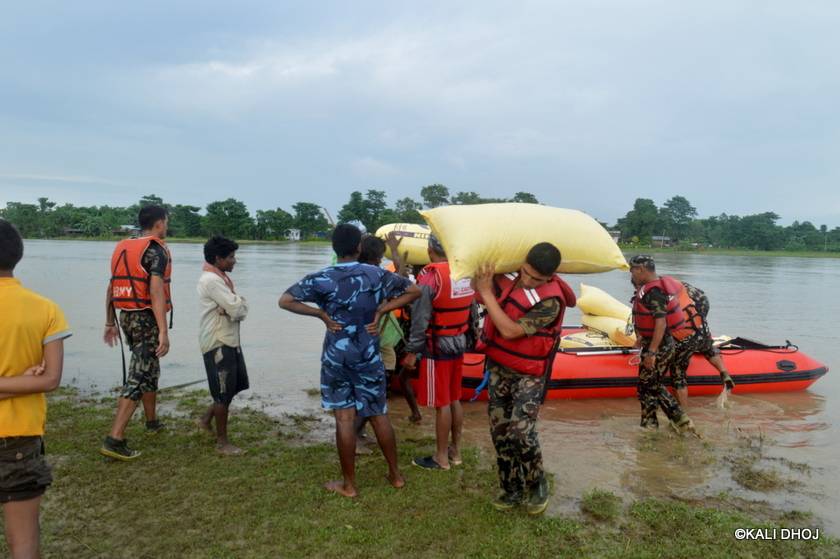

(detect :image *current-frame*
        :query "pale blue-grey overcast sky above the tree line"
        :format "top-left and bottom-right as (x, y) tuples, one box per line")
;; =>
(0, 0), (840, 227)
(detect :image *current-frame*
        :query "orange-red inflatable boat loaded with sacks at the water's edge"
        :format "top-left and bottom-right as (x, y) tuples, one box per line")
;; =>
(408, 329), (828, 400)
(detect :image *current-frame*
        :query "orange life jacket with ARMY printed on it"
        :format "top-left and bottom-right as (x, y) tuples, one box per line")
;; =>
(111, 236), (172, 311)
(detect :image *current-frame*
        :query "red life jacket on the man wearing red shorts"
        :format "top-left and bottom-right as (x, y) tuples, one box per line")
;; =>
(420, 262), (475, 339)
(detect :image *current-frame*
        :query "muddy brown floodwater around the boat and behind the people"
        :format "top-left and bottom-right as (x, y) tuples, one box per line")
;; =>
(17, 241), (840, 534)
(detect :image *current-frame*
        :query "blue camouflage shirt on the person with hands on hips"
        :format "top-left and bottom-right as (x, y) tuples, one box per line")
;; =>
(286, 262), (411, 372)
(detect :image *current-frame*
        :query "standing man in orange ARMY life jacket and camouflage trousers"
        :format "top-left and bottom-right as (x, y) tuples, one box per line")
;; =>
(99, 206), (172, 460)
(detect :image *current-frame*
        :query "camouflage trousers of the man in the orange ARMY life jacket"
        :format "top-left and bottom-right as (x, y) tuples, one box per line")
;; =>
(120, 310), (160, 402)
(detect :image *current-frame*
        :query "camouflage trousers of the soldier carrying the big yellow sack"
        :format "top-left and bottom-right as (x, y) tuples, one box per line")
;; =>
(487, 367), (545, 494)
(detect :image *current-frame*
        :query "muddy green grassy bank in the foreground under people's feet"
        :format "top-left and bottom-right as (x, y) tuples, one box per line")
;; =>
(0, 392), (840, 559)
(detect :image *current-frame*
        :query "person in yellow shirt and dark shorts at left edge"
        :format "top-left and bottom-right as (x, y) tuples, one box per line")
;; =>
(0, 219), (71, 559)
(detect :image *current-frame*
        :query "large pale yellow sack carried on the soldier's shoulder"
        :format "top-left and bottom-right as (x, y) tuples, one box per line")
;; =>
(420, 203), (628, 279)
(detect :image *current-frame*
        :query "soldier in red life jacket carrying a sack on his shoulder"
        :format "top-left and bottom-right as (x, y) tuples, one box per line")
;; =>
(473, 243), (577, 515)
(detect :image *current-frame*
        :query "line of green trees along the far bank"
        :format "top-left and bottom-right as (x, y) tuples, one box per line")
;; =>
(0, 188), (840, 251)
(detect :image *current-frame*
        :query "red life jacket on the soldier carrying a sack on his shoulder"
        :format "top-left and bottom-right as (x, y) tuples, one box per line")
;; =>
(477, 274), (577, 376)
